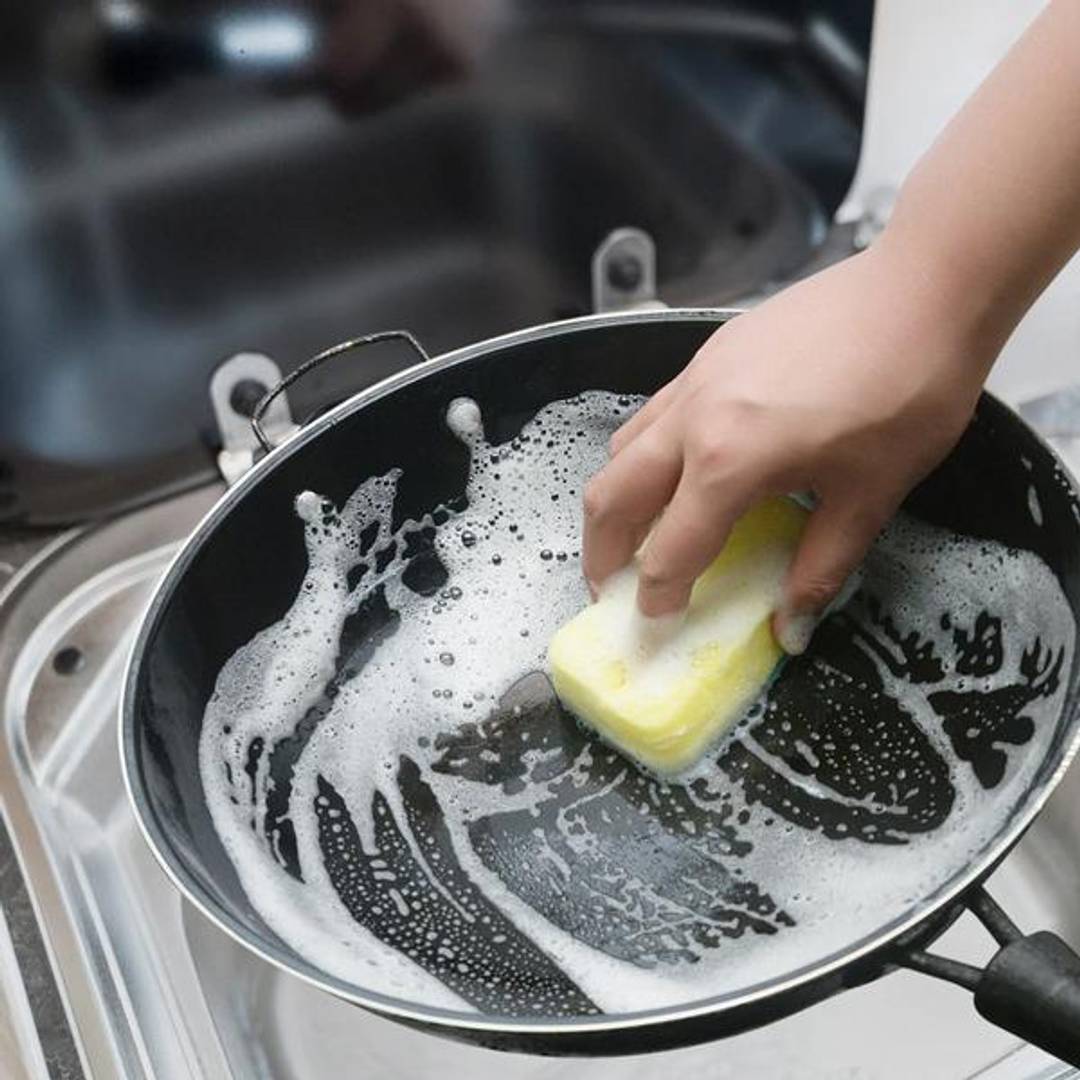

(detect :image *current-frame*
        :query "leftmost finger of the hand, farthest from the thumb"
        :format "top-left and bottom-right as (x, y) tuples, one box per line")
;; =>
(581, 423), (683, 595)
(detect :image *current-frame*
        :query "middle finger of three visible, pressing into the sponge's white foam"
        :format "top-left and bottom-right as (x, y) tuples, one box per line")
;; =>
(637, 471), (755, 617)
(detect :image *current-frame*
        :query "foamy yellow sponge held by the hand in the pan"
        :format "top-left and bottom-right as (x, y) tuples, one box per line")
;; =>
(548, 498), (807, 773)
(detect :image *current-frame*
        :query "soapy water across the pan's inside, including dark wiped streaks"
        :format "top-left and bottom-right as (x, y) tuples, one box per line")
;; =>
(200, 391), (1075, 1016)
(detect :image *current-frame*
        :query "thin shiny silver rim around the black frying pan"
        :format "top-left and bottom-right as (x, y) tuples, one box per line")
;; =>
(118, 308), (1080, 1040)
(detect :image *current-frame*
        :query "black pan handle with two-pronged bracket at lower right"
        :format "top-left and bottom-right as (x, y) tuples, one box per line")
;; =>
(897, 886), (1080, 1066)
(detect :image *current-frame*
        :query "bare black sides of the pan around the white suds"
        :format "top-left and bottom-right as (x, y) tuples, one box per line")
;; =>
(123, 312), (1080, 1052)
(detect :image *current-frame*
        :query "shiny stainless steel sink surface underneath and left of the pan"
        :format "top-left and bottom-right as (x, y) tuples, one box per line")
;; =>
(0, 477), (1080, 1080)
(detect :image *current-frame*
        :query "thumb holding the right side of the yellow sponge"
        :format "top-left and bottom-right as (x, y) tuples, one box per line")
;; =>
(773, 498), (893, 656)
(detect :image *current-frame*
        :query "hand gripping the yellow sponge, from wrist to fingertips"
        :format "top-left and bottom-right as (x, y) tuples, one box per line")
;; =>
(583, 245), (1000, 652)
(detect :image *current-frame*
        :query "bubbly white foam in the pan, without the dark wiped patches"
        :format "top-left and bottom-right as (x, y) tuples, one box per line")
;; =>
(200, 391), (1074, 1012)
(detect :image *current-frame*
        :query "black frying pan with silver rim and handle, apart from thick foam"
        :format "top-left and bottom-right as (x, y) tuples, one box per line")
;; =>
(121, 310), (1080, 1064)
